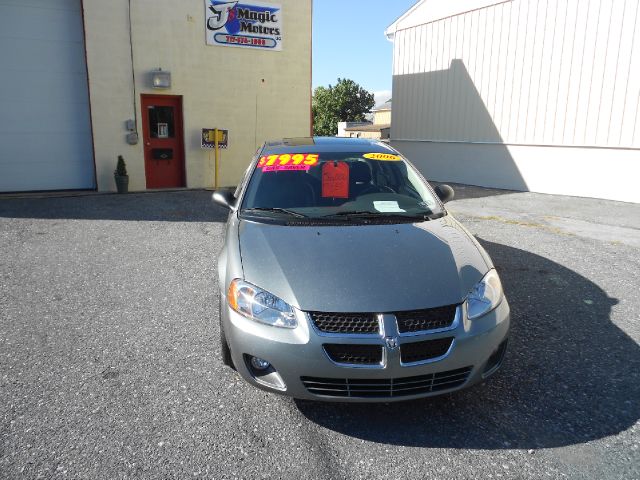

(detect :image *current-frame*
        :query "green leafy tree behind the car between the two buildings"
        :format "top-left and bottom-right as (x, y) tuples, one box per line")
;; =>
(312, 78), (375, 135)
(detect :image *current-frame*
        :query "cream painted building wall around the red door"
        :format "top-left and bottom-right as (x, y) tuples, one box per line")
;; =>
(83, 0), (311, 190)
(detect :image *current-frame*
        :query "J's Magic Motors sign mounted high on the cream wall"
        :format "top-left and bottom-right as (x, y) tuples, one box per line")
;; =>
(204, 0), (282, 50)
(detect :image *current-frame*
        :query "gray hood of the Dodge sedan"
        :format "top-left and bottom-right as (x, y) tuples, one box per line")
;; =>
(238, 215), (491, 312)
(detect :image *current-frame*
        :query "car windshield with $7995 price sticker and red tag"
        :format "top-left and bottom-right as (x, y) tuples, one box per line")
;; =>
(241, 151), (440, 218)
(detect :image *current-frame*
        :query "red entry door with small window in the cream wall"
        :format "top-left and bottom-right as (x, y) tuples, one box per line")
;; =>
(140, 95), (185, 188)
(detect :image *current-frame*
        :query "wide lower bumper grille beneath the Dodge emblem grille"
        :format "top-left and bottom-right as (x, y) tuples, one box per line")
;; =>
(300, 367), (472, 398)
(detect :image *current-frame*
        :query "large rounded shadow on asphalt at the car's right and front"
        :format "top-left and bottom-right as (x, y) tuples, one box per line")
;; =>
(296, 241), (640, 449)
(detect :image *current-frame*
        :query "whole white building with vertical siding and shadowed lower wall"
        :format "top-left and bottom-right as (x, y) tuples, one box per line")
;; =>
(385, 0), (640, 202)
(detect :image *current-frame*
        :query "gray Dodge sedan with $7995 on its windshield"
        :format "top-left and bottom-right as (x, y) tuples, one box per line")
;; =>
(213, 138), (509, 402)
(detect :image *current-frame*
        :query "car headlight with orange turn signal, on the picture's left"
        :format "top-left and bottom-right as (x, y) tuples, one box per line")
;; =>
(227, 278), (298, 328)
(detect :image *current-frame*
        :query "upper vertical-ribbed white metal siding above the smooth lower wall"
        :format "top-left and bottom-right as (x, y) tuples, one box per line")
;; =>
(391, 0), (640, 148)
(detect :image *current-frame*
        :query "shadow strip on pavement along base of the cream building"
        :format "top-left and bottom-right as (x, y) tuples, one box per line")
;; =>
(0, 190), (228, 222)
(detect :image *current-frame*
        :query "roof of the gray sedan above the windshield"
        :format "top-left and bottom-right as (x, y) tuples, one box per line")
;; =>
(262, 137), (397, 154)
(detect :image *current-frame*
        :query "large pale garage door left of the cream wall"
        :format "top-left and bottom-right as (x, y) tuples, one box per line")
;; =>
(0, 0), (95, 192)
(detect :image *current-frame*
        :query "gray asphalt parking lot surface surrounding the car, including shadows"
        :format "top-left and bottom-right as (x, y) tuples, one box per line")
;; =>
(0, 186), (640, 479)
